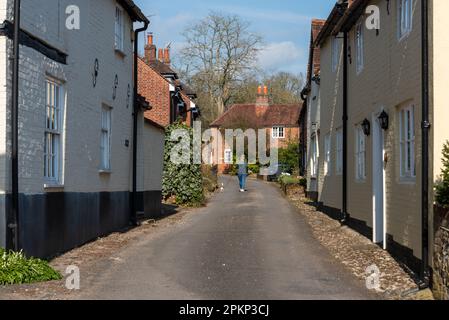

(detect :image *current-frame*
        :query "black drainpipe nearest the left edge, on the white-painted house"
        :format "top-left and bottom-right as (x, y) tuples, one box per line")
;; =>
(8, 0), (21, 251)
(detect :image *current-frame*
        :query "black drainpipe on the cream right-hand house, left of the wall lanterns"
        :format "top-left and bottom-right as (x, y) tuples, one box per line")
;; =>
(341, 31), (349, 224)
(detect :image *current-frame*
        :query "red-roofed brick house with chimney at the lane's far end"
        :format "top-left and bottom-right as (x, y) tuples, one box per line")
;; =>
(211, 87), (302, 173)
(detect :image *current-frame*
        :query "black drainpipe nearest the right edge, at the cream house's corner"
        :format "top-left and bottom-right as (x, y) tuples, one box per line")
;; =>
(420, 0), (431, 289)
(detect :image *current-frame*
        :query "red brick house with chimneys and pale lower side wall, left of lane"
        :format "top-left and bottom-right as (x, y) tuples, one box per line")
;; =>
(137, 34), (199, 217)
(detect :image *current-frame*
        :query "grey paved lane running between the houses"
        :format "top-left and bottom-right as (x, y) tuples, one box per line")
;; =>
(82, 178), (374, 299)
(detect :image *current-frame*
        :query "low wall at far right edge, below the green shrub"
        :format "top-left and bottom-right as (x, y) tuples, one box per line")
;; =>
(433, 208), (449, 300)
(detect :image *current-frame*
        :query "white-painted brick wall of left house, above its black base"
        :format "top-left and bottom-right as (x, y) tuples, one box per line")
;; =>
(0, 0), (133, 194)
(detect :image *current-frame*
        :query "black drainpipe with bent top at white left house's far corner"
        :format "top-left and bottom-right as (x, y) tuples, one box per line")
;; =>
(130, 21), (149, 226)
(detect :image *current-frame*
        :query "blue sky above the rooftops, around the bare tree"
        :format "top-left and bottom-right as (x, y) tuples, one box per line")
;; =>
(135, 0), (335, 73)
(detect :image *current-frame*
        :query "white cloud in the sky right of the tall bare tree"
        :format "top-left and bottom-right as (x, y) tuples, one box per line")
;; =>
(259, 41), (304, 72)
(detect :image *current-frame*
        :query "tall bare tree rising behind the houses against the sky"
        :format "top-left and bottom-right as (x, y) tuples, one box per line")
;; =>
(180, 12), (262, 119)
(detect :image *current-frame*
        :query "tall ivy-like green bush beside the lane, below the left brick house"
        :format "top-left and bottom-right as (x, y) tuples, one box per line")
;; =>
(162, 123), (204, 206)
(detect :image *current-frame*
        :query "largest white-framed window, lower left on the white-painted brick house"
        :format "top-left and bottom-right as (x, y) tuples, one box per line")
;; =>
(44, 79), (64, 184)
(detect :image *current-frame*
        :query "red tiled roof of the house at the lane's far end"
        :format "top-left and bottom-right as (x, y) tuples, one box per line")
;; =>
(211, 104), (302, 129)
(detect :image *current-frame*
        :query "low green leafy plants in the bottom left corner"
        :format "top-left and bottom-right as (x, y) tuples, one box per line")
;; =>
(0, 248), (62, 285)
